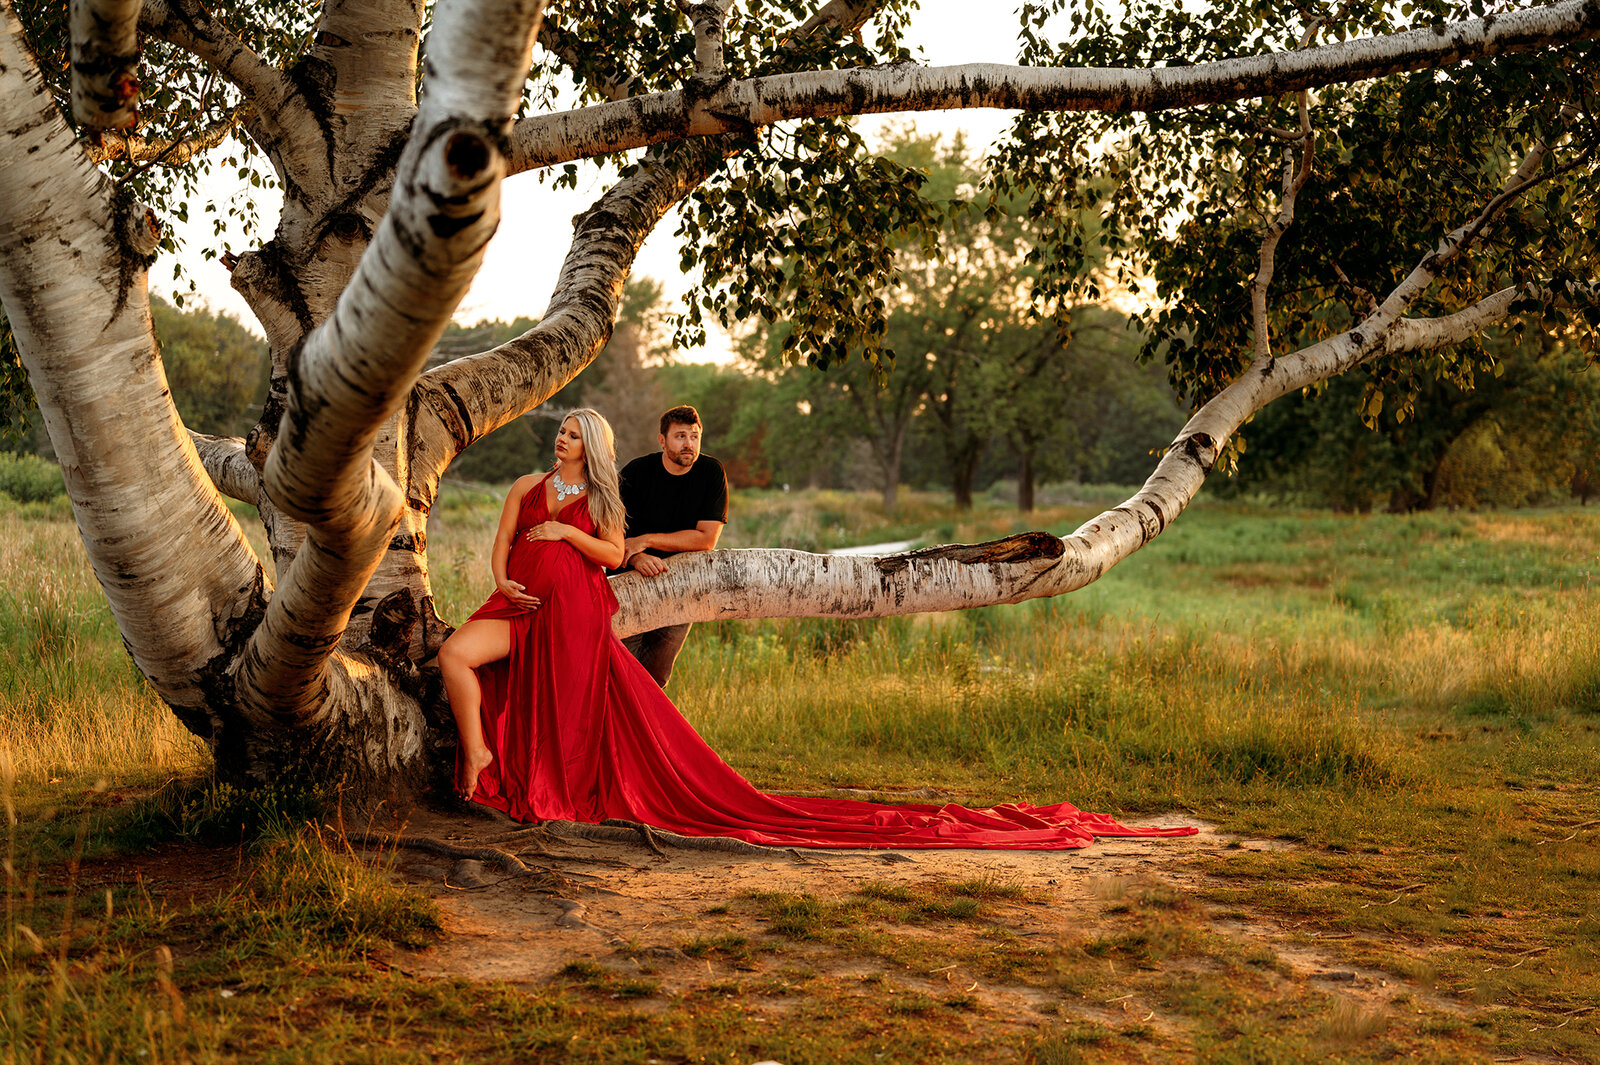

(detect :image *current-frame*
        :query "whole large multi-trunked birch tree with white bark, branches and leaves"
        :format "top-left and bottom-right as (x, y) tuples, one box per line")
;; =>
(0, 0), (1600, 795)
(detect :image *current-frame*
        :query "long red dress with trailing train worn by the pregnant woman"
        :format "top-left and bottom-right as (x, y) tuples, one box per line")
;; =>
(472, 480), (1195, 849)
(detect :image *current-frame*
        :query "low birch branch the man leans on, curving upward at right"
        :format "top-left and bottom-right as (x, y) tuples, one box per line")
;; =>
(611, 127), (1600, 636)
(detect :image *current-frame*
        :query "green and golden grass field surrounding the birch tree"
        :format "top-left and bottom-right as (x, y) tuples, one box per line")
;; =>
(0, 488), (1600, 1065)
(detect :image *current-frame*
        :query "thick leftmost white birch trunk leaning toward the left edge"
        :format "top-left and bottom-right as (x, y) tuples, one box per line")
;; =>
(0, 6), (270, 737)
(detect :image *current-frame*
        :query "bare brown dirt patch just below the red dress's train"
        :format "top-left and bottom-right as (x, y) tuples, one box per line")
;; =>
(363, 812), (1454, 1035)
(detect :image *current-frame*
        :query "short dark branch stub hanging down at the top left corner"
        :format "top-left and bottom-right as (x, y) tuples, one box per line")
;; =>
(67, 0), (139, 130)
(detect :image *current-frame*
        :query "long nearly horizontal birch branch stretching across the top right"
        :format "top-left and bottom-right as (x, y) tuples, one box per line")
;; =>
(510, 0), (1600, 173)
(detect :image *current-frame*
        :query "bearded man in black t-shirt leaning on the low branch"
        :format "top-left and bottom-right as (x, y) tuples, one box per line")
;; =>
(621, 406), (728, 688)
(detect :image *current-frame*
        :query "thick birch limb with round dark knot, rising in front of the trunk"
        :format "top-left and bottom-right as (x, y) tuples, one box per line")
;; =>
(235, 0), (544, 721)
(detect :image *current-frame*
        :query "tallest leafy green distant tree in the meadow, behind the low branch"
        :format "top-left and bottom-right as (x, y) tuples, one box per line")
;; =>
(752, 128), (1152, 510)
